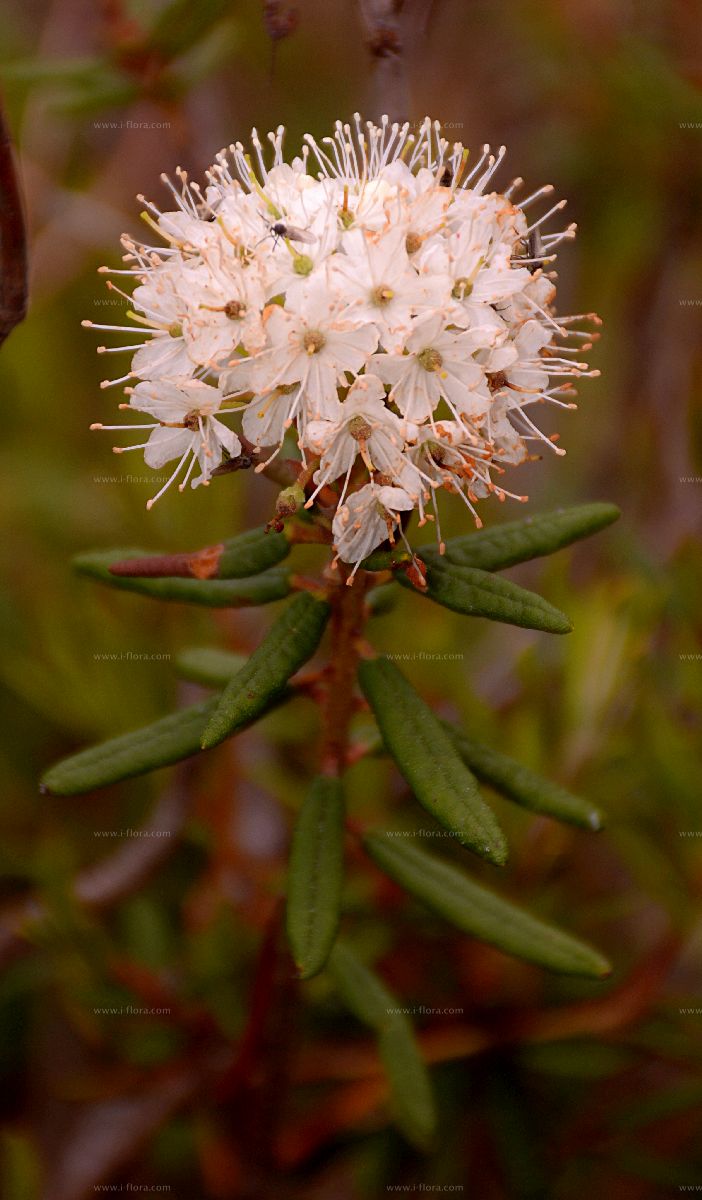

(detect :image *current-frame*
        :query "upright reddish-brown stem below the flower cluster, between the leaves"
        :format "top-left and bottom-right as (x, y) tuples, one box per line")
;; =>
(322, 564), (367, 775)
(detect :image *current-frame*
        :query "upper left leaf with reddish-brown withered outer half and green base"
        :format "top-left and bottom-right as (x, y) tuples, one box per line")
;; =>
(109, 527), (290, 580)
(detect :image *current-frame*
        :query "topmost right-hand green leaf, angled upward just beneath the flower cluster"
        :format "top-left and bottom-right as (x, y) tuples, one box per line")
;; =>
(416, 504), (620, 571)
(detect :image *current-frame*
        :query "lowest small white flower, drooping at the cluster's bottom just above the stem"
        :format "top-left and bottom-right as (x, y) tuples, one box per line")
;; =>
(332, 482), (414, 574)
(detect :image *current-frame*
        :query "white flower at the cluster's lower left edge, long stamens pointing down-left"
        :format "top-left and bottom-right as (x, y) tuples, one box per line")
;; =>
(91, 379), (241, 509)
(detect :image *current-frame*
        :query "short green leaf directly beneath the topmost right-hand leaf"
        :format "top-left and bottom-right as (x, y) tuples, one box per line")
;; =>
(397, 559), (572, 634)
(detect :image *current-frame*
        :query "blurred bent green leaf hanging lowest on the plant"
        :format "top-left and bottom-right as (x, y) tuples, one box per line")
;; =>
(329, 942), (437, 1147)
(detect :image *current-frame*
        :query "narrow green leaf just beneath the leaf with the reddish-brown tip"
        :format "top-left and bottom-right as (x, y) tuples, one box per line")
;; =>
(73, 550), (290, 608)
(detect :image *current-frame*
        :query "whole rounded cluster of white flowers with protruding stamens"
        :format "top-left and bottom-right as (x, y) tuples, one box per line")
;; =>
(85, 116), (596, 564)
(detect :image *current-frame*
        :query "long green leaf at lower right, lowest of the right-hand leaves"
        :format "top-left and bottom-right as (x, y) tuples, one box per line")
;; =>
(364, 833), (611, 979)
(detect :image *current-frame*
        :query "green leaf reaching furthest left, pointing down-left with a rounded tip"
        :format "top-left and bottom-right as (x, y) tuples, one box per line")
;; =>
(42, 698), (217, 796)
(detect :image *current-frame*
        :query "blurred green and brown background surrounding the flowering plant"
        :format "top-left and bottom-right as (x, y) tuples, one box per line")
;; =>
(0, 0), (702, 1200)
